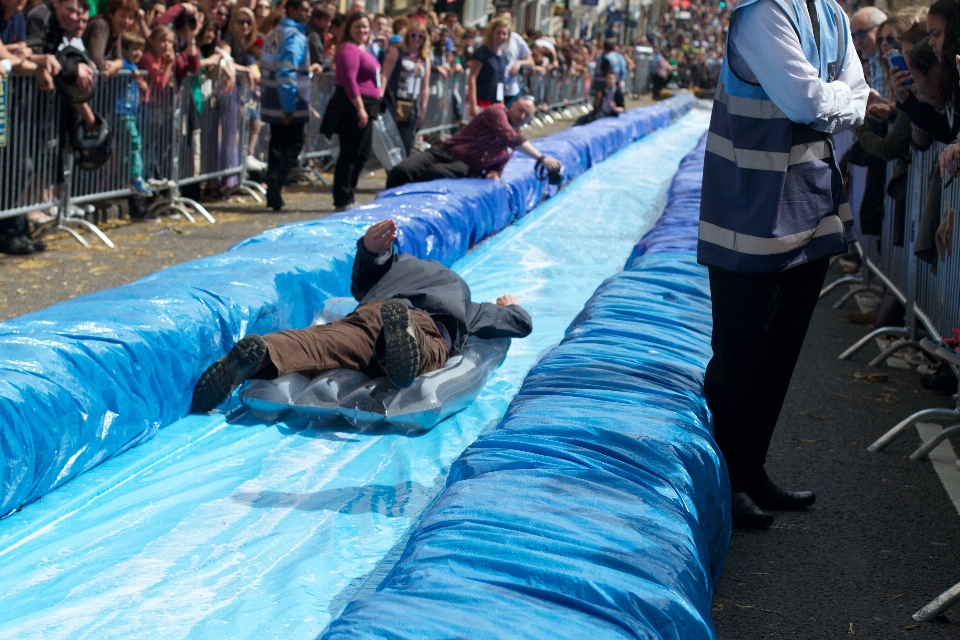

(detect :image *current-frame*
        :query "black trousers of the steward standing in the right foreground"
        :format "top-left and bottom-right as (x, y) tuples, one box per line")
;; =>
(703, 258), (829, 492)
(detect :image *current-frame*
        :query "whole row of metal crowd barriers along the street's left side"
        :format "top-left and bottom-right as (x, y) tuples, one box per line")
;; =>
(0, 57), (649, 247)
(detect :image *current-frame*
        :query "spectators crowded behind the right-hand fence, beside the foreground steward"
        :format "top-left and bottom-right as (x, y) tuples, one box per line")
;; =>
(840, 0), (960, 393)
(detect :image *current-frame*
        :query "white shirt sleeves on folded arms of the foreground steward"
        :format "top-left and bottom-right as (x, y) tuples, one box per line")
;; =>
(729, 0), (870, 133)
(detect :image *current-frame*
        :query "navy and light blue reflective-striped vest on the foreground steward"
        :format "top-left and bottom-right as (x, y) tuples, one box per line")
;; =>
(697, 0), (853, 273)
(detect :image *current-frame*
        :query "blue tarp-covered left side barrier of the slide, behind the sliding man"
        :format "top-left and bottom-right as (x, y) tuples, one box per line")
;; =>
(0, 95), (695, 516)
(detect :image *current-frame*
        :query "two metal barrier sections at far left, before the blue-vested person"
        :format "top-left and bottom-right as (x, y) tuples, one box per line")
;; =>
(0, 71), (262, 247)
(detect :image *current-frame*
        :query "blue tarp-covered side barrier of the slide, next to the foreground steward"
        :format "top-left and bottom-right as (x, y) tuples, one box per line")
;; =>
(323, 135), (731, 640)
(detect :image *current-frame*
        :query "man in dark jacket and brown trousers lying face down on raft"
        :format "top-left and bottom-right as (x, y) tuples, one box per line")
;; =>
(193, 220), (533, 411)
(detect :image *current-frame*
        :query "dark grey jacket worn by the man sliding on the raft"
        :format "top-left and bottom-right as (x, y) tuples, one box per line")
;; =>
(350, 238), (533, 346)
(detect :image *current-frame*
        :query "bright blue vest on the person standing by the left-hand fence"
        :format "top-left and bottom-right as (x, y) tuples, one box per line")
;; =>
(260, 22), (310, 123)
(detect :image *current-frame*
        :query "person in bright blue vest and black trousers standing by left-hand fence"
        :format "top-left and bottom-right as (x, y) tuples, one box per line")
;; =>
(260, 0), (310, 211)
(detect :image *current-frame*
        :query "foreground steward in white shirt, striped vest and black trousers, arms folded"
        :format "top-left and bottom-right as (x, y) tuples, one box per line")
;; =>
(697, 0), (869, 529)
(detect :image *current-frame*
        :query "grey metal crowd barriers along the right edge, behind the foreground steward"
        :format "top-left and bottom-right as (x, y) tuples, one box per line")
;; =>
(823, 134), (960, 622)
